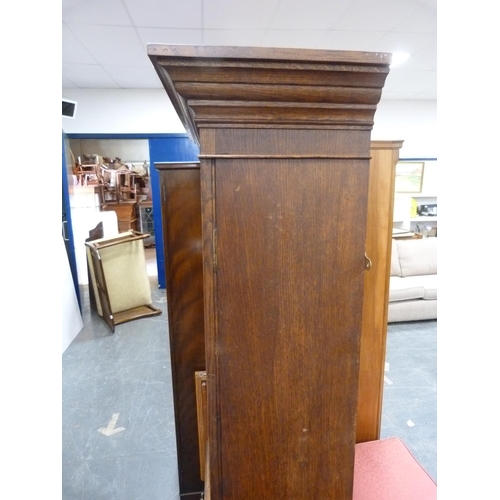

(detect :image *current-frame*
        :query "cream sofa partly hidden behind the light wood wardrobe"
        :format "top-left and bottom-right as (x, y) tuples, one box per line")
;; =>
(387, 238), (437, 323)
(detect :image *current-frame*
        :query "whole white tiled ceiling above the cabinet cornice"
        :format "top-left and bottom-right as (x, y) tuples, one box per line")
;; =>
(62, 0), (437, 99)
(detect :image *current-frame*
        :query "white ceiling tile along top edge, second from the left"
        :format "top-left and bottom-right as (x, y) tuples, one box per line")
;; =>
(124, 0), (202, 29)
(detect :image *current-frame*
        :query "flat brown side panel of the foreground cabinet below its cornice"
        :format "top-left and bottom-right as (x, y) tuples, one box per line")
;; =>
(214, 159), (368, 500)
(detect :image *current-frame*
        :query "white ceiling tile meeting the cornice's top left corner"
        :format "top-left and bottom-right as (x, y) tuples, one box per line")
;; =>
(69, 24), (149, 66)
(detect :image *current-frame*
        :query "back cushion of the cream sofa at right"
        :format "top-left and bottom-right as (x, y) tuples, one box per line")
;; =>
(396, 238), (437, 276)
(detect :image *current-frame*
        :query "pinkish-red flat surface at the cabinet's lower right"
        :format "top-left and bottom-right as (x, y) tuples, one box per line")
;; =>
(353, 438), (437, 500)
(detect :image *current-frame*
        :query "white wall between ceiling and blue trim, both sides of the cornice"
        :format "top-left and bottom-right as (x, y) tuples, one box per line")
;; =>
(62, 89), (437, 158)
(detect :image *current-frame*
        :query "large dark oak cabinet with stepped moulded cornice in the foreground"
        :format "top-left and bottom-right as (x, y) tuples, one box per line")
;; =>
(148, 45), (390, 500)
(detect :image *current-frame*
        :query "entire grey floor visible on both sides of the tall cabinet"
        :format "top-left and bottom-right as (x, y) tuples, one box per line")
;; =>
(62, 248), (437, 500)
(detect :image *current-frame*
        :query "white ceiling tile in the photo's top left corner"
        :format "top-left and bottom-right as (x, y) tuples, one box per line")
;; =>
(62, 0), (132, 26)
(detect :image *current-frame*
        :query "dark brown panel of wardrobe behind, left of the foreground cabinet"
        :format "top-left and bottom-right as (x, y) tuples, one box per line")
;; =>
(160, 168), (205, 494)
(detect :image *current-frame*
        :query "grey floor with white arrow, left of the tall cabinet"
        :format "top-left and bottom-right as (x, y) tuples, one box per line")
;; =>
(62, 251), (179, 500)
